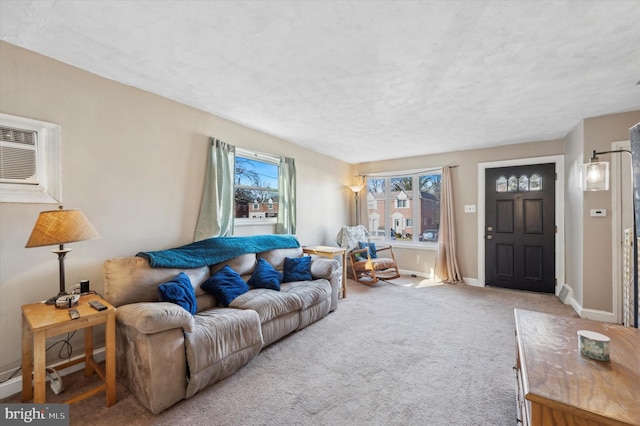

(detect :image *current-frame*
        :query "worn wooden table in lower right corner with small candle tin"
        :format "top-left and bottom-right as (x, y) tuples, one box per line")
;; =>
(515, 309), (640, 426)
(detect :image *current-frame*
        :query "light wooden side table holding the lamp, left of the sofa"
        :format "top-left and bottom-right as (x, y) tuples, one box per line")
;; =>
(22, 295), (116, 407)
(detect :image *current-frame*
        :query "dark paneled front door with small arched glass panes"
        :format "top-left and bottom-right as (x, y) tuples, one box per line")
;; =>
(485, 164), (556, 293)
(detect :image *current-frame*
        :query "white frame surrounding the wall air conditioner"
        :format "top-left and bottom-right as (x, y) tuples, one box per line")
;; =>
(0, 113), (62, 204)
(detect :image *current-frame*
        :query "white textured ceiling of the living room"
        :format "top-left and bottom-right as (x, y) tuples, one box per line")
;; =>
(0, 0), (640, 163)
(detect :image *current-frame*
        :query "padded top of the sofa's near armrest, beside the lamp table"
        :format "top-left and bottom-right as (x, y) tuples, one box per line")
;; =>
(116, 302), (195, 334)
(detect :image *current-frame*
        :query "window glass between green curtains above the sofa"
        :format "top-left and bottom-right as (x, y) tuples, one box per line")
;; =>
(235, 156), (278, 219)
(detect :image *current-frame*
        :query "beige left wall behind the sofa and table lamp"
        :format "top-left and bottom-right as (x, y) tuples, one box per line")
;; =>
(0, 42), (353, 377)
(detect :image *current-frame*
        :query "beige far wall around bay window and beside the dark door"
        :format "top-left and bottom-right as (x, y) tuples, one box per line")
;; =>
(357, 140), (564, 279)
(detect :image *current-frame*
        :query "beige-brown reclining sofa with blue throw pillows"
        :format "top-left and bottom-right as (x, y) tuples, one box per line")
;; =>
(104, 241), (341, 413)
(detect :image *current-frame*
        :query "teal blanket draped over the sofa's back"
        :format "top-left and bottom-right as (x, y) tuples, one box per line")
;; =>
(136, 235), (300, 269)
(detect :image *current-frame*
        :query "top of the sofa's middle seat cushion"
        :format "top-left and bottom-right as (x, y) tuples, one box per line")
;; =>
(229, 288), (302, 324)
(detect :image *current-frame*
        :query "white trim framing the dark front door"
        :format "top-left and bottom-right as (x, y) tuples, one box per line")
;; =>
(478, 155), (565, 295)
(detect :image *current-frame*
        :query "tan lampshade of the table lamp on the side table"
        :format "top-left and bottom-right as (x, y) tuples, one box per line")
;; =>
(25, 206), (100, 248)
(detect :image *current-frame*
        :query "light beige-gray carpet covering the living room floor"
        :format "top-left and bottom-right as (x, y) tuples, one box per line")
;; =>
(3, 277), (576, 426)
